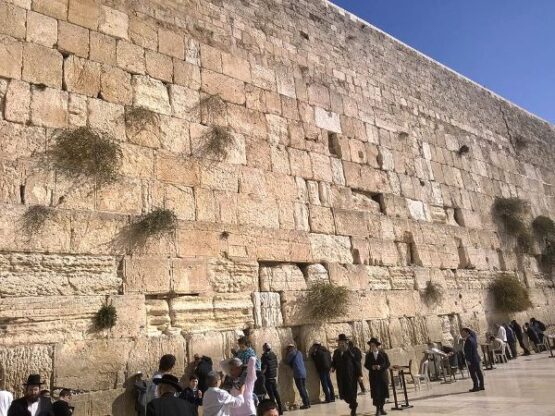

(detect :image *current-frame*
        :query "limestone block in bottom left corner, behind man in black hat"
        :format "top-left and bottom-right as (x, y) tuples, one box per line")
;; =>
(0, 343), (54, 398)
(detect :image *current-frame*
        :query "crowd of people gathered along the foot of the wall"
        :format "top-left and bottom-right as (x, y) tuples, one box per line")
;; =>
(0, 318), (546, 416)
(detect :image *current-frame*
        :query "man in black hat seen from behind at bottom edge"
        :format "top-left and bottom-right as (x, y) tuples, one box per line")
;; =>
(146, 374), (196, 416)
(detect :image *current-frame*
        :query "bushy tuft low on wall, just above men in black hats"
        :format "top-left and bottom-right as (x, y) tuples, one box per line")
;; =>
(306, 282), (349, 320)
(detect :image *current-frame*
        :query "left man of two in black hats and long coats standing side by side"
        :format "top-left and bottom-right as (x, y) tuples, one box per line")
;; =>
(331, 334), (362, 416)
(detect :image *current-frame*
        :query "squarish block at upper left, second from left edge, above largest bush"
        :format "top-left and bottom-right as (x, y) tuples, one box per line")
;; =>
(22, 43), (62, 89)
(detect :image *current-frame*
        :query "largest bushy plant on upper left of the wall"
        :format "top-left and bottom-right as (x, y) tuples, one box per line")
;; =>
(47, 127), (122, 186)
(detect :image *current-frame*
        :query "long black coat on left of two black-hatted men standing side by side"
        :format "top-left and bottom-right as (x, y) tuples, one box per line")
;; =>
(331, 348), (362, 403)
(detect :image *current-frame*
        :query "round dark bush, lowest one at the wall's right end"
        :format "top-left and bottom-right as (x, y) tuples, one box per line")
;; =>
(489, 275), (532, 313)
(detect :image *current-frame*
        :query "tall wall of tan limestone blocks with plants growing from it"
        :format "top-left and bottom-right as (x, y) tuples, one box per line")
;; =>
(0, 0), (555, 416)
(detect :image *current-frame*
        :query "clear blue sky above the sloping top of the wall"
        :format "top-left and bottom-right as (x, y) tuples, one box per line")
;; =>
(332, 0), (555, 123)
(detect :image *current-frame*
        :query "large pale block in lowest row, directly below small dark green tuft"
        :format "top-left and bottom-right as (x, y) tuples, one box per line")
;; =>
(53, 339), (134, 390)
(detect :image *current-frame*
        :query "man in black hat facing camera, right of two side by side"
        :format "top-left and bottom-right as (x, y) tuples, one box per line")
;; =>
(364, 338), (390, 415)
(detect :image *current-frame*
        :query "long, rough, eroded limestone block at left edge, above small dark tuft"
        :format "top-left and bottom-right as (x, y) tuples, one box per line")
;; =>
(0, 253), (121, 297)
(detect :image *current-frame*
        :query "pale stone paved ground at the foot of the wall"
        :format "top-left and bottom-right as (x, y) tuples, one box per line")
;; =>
(285, 352), (555, 416)
